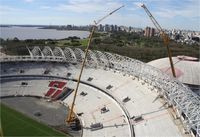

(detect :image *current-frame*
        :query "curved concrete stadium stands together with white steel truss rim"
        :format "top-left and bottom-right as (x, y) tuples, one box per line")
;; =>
(0, 46), (200, 137)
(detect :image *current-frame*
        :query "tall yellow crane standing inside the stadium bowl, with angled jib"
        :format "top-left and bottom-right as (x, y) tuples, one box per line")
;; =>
(66, 5), (124, 124)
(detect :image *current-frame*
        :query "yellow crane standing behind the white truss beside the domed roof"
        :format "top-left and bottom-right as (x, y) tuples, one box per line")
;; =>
(141, 4), (176, 77)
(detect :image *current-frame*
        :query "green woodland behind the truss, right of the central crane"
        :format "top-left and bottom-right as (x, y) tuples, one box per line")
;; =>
(91, 32), (200, 62)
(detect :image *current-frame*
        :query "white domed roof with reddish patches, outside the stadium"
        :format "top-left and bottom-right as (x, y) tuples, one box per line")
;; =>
(148, 56), (200, 86)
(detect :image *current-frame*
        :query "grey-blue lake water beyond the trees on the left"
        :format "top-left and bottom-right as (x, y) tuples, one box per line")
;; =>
(0, 27), (89, 40)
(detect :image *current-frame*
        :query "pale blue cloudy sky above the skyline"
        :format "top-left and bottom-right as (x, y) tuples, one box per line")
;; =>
(0, 0), (200, 30)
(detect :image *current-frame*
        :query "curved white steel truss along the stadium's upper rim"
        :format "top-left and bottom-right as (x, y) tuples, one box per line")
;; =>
(0, 46), (200, 136)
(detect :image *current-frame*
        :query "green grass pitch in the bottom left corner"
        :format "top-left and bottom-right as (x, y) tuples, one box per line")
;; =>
(0, 103), (67, 137)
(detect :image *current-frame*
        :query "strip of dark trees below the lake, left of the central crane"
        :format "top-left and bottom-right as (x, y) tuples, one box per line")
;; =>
(0, 36), (81, 55)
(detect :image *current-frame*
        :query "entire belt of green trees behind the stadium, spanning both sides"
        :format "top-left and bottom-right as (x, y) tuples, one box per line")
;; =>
(0, 32), (200, 62)
